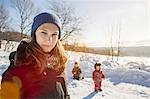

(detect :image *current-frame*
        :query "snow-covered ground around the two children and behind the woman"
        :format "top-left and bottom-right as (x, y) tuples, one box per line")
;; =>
(0, 49), (150, 99)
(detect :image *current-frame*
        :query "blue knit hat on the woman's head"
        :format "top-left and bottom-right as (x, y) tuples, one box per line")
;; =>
(31, 13), (61, 39)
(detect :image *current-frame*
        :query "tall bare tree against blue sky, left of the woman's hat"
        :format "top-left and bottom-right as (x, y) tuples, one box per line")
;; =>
(12, 0), (35, 39)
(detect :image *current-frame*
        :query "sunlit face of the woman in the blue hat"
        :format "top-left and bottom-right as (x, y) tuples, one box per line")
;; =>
(35, 23), (59, 52)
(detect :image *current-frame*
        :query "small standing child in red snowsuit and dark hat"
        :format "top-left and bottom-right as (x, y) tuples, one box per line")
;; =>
(92, 63), (105, 92)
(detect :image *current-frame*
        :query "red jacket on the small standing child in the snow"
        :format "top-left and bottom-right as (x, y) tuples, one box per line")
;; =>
(92, 70), (105, 82)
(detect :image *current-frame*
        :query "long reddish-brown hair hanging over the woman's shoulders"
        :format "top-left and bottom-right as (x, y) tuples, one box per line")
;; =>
(16, 34), (67, 74)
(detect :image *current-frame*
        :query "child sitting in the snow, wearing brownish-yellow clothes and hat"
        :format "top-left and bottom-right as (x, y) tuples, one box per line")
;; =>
(72, 62), (84, 80)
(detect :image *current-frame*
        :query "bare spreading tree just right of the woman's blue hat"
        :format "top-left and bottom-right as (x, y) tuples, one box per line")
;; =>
(48, 0), (81, 41)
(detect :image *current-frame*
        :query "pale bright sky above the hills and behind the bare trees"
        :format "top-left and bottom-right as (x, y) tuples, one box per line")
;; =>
(0, 0), (150, 47)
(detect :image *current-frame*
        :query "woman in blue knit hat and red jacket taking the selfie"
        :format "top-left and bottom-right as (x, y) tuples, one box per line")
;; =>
(0, 13), (69, 99)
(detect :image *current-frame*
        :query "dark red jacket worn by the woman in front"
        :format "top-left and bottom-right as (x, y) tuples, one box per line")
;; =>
(2, 65), (64, 99)
